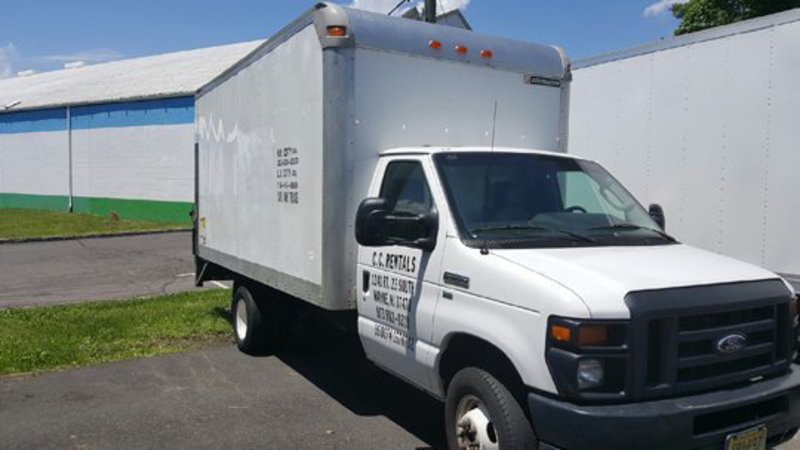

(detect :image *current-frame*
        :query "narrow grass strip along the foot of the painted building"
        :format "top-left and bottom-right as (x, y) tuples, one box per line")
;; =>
(0, 209), (191, 240)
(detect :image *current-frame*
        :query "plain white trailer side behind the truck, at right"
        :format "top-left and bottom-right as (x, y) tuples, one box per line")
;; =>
(570, 9), (800, 283)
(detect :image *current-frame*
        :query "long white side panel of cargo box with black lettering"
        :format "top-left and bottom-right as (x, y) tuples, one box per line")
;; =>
(197, 27), (323, 304)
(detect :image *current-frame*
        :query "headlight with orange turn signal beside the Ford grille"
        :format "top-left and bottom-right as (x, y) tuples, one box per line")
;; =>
(546, 317), (629, 400)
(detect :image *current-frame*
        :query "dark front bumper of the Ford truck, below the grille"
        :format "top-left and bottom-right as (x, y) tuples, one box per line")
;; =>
(528, 365), (800, 450)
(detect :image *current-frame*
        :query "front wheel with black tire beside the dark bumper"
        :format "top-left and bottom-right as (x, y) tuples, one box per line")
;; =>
(444, 367), (538, 450)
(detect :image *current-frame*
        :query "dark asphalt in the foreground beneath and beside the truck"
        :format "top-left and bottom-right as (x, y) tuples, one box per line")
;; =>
(0, 342), (444, 449)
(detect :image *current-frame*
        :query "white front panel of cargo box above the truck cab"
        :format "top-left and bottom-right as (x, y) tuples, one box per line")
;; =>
(325, 48), (563, 305)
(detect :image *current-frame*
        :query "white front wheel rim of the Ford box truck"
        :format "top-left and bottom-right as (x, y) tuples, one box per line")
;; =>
(455, 395), (499, 450)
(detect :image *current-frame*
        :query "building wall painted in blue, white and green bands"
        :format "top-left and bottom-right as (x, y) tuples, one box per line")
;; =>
(0, 96), (195, 222)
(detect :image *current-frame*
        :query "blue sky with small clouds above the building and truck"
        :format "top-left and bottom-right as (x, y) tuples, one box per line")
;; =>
(0, 0), (679, 77)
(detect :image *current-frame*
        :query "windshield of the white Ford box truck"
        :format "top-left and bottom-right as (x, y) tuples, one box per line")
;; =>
(434, 152), (675, 248)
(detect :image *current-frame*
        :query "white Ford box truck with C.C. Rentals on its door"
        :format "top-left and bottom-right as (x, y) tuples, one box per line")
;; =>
(194, 3), (800, 450)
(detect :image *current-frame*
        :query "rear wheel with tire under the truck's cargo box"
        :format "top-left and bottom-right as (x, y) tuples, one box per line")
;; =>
(231, 285), (275, 355)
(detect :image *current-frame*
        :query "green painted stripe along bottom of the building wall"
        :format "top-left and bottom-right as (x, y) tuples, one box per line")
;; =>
(0, 193), (193, 223)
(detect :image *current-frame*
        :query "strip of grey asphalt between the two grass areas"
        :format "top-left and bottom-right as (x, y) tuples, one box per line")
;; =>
(0, 232), (219, 308)
